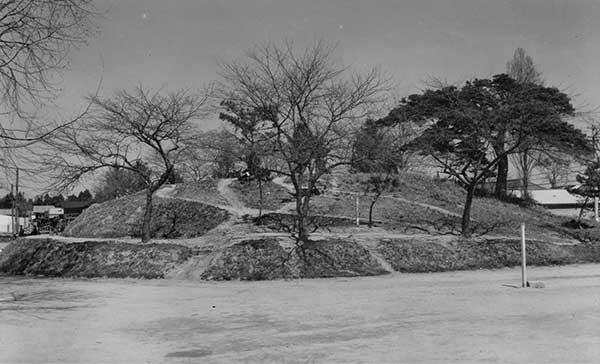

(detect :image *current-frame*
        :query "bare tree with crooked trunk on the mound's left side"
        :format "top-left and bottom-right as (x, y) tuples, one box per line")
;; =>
(47, 87), (207, 242)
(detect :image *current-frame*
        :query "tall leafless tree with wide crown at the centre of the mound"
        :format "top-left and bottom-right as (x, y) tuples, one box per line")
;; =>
(220, 41), (389, 246)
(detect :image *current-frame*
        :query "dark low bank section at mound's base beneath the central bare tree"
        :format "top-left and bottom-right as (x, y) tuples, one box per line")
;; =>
(202, 239), (388, 280)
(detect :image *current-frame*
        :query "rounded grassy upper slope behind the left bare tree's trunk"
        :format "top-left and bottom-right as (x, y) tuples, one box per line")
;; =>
(64, 193), (229, 239)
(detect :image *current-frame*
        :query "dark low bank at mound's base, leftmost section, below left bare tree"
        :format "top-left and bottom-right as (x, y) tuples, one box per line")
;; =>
(0, 239), (192, 278)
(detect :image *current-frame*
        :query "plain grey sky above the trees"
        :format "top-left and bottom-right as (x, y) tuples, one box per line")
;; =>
(8, 0), (600, 193)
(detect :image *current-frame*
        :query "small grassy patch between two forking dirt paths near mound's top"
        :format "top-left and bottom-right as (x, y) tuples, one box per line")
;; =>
(229, 180), (291, 210)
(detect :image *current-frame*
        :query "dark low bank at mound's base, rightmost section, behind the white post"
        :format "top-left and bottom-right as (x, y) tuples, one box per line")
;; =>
(377, 239), (600, 273)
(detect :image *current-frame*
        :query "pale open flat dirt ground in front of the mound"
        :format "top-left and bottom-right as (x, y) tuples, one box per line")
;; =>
(0, 265), (600, 364)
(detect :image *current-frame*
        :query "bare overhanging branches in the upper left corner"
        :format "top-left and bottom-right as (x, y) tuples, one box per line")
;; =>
(0, 0), (98, 175)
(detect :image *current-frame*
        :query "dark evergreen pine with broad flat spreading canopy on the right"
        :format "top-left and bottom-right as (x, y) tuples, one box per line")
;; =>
(379, 74), (591, 236)
